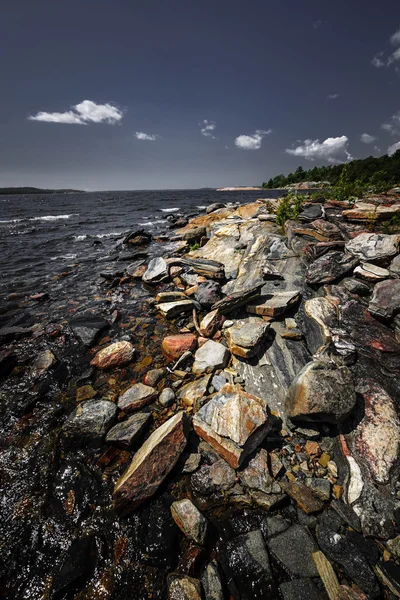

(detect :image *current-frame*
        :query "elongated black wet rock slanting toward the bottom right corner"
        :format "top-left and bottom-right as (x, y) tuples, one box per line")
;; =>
(317, 527), (381, 598)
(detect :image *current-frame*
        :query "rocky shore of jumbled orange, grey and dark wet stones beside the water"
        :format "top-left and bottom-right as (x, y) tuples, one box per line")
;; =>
(0, 193), (400, 600)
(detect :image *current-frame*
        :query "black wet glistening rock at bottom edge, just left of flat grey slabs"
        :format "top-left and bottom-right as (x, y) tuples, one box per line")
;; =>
(218, 531), (276, 600)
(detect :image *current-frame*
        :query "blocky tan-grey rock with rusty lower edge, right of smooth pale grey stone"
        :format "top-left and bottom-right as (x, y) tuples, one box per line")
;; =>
(225, 317), (269, 358)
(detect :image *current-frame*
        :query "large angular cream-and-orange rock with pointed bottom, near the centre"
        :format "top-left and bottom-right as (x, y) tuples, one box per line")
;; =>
(193, 385), (271, 468)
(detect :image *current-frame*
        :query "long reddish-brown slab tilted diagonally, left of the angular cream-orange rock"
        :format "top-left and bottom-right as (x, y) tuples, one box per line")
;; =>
(114, 412), (190, 515)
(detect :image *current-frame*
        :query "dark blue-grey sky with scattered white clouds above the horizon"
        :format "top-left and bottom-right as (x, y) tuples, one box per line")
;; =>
(0, 0), (400, 190)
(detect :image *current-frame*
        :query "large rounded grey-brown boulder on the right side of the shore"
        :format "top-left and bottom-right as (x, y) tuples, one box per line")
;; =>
(285, 361), (356, 424)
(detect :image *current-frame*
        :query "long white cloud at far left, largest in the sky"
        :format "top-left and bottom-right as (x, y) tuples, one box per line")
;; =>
(28, 100), (123, 125)
